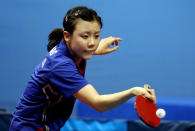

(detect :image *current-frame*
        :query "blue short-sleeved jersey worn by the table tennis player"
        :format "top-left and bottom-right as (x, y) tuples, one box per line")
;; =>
(10, 41), (88, 131)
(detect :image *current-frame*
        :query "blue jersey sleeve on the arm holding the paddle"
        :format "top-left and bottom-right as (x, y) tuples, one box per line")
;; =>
(49, 62), (89, 98)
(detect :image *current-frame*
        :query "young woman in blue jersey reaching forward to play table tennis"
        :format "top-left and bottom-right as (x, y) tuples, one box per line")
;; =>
(10, 7), (156, 131)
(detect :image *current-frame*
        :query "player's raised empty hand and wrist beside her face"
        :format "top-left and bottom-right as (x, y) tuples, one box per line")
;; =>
(94, 37), (122, 55)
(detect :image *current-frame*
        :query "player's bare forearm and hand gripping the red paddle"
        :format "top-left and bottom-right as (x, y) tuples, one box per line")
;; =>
(74, 84), (156, 112)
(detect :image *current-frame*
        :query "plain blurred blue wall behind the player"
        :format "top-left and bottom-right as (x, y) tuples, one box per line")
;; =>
(0, 0), (195, 130)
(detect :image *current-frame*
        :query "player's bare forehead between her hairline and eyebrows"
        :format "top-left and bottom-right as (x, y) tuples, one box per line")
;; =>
(74, 19), (100, 33)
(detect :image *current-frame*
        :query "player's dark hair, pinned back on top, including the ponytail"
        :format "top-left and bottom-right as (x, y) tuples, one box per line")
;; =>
(47, 6), (102, 51)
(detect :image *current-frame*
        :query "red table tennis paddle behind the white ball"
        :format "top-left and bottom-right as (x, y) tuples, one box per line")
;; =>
(134, 84), (160, 127)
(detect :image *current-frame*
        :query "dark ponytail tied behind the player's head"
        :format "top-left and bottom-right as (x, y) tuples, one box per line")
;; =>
(47, 28), (64, 51)
